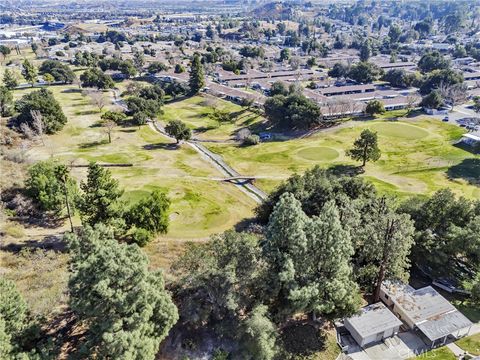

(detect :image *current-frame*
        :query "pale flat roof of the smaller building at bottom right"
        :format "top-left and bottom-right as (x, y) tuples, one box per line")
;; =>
(345, 302), (402, 338)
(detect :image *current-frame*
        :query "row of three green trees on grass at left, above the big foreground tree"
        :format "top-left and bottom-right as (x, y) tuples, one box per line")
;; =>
(25, 161), (170, 246)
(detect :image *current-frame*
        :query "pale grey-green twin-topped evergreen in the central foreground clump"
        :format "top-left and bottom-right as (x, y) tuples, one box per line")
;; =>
(264, 193), (358, 317)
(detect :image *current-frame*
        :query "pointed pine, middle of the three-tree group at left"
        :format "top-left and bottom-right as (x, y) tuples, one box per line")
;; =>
(79, 163), (123, 226)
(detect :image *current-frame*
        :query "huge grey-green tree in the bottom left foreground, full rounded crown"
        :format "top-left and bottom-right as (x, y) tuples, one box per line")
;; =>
(67, 225), (178, 360)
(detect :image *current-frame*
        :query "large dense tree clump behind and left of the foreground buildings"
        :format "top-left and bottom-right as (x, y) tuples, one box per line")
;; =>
(172, 168), (414, 359)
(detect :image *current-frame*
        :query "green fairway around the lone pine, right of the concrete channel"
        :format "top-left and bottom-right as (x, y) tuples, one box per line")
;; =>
(208, 117), (480, 198)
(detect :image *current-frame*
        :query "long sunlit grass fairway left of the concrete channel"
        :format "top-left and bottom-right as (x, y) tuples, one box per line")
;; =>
(15, 86), (254, 240)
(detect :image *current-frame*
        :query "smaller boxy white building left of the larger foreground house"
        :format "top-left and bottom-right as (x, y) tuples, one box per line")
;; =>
(344, 302), (403, 347)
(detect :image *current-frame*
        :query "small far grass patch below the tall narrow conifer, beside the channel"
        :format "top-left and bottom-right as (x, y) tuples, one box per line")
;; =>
(160, 95), (264, 140)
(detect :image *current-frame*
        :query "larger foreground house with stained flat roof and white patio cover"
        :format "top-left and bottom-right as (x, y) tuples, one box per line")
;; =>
(380, 281), (472, 347)
